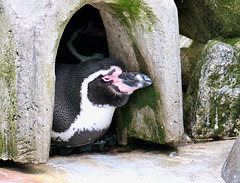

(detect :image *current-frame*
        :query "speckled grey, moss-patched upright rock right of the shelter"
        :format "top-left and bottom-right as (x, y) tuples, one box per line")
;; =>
(184, 41), (240, 138)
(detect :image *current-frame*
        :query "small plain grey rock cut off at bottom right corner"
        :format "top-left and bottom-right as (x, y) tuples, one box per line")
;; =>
(222, 137), (240, 183)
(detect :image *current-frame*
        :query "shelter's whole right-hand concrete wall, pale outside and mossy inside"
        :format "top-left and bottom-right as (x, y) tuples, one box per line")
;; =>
(101, 1), (183, 145)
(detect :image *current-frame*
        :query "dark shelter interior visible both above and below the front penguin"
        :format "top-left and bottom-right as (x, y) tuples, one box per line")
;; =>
(50, 5), (117, 156)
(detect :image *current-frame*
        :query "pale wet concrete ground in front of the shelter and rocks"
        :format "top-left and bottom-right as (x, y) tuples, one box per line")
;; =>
(0, 140), (235, 183)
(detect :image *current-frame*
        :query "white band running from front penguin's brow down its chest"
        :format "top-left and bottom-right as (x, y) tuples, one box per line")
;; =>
(52, 66), (118, 141)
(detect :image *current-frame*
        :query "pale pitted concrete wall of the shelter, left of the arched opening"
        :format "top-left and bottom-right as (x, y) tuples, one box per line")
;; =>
(0, 0), (58, 163)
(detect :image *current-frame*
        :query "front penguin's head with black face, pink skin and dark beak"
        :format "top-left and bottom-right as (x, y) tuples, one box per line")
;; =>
(88, 59), (152, 107)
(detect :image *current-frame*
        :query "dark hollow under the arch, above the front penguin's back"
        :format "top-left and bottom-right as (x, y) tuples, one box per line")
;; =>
(56, 5), (109, 64)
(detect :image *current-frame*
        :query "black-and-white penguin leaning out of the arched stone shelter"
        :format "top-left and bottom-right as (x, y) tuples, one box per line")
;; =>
(52, 58), (152, 147)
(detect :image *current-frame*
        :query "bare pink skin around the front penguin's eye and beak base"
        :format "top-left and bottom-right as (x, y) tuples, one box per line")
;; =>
(102, 67), (138, 93)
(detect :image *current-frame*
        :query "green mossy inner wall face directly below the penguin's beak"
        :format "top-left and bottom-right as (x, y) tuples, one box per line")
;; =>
(117, 86), (165, 144)
